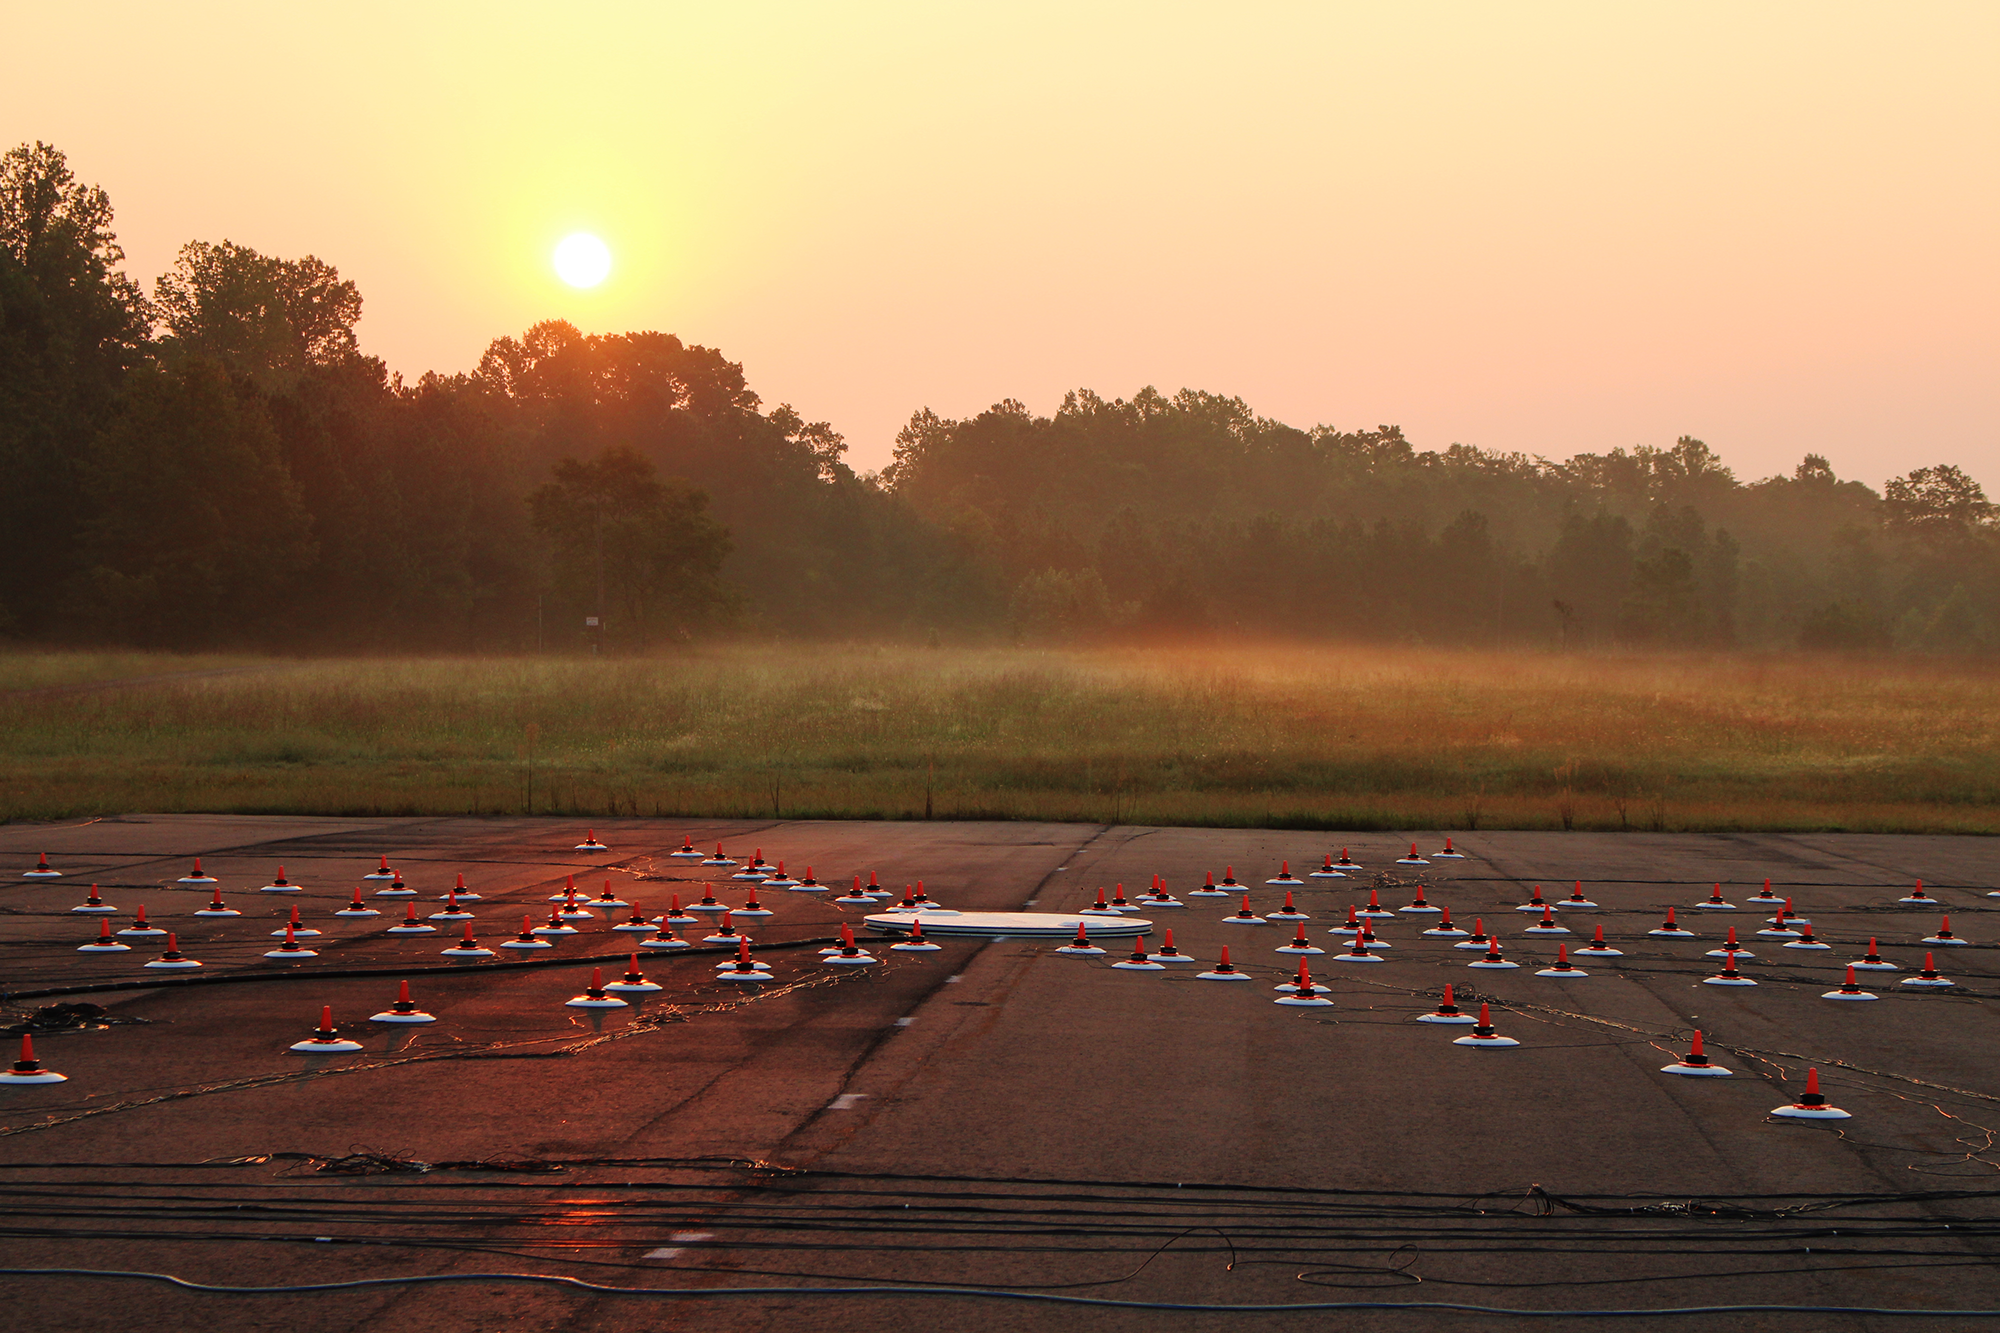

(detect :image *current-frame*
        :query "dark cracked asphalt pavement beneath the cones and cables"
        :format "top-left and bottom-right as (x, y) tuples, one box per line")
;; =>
(0, 817), (2000, 1331)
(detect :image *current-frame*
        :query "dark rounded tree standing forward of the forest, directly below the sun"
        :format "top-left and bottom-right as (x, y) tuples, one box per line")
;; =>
(528, 446), (736, 646)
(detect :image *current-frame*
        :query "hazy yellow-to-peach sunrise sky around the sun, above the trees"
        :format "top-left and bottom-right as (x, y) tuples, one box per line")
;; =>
(0, 0), (2000, 490)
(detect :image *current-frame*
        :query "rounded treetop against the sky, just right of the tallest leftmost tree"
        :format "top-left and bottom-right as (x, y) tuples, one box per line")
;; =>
(154, 240), (362, 374)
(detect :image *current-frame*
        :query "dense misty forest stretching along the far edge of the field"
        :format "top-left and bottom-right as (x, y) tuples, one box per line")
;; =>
(0, 144), (2000, 652)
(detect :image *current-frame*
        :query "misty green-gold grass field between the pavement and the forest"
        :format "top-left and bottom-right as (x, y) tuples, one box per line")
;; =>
(0, 644), (2000, 833)
